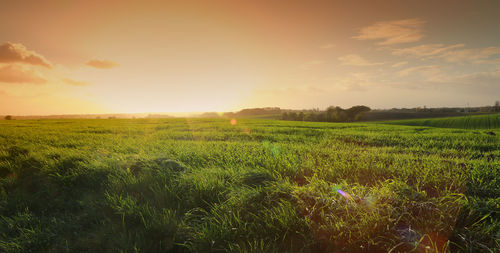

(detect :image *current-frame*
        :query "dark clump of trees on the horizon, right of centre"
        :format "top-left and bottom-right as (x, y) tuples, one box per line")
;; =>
(281, 105), (371, 122)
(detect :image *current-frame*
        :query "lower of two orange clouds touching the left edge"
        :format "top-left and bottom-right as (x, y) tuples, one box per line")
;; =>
(0, 64), (47, 84)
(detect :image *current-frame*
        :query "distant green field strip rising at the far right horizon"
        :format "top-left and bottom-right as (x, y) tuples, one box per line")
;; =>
(383, 113), (500, 129)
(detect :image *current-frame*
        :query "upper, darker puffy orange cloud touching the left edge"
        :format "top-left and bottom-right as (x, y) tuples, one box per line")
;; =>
(0, 42), (52, 68)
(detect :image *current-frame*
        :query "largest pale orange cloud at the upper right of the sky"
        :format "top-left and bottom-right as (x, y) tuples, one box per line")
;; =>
(353, 18), (426, 45)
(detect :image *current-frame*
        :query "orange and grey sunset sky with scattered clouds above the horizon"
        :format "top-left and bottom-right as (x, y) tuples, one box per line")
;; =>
(0, 0), (500, 115)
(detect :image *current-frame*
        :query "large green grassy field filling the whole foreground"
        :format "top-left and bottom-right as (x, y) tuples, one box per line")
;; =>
(0, 118), (500, 252)
